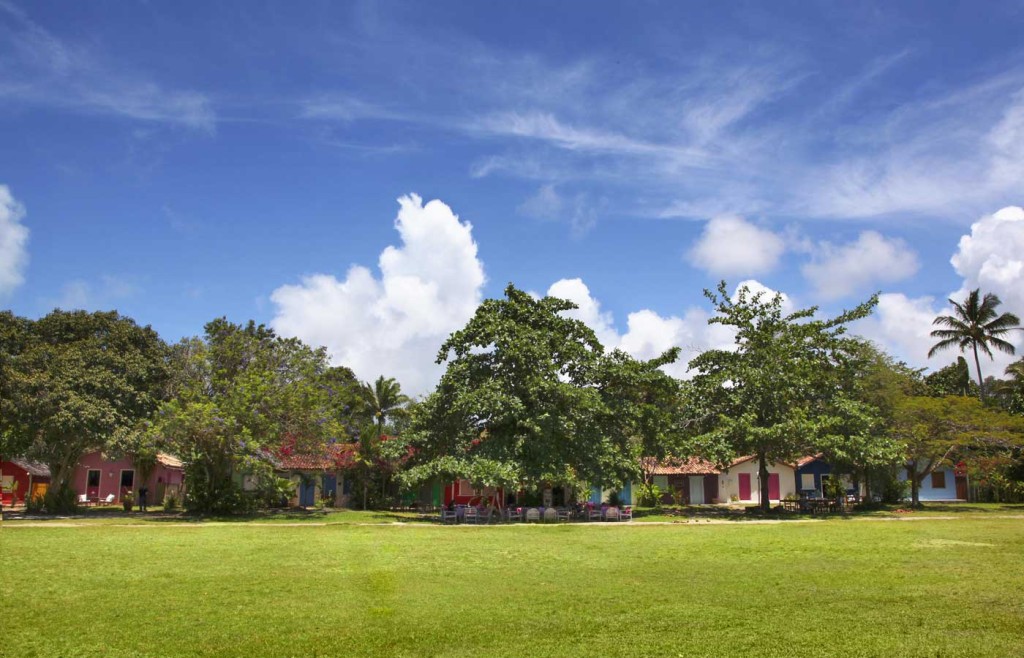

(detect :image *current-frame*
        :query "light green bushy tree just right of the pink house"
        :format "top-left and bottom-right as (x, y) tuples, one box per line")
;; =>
(156, 318), (343, 513)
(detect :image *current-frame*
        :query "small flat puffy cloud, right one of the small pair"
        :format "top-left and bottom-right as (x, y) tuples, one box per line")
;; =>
(801, 230), (920, 300)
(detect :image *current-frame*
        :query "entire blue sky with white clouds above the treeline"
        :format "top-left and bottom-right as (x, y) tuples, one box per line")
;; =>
(0, 1), (1024, 392)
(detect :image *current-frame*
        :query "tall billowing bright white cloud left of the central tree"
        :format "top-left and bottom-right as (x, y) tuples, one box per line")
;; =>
(270, 194), (484, 394)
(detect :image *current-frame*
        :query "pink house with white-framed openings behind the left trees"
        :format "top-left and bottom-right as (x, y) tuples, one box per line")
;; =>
(73, 451), (184, 505)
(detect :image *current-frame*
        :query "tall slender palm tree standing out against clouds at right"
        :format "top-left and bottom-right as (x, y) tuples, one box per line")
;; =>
(928, 289), (1021, 399)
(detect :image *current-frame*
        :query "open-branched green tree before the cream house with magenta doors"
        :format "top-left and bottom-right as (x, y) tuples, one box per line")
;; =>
(688, 281), (878, 511)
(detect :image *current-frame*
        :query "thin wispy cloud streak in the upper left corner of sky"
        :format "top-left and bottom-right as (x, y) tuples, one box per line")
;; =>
(0, 2), (217, 132)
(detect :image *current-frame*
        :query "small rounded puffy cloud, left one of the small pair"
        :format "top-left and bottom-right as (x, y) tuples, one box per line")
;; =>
(688, 215), (785, 276)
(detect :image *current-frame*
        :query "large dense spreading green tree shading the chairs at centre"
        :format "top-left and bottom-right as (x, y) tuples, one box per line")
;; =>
(404, 284), (671, 505)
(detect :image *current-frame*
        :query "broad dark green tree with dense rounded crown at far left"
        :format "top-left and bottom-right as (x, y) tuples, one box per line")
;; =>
(3, 310), (167, 512)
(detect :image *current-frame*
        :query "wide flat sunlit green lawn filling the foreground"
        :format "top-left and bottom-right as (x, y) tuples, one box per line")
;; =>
(0, 513), (1024, 658)
